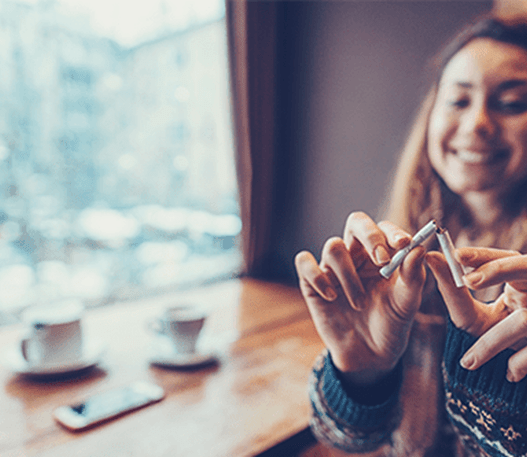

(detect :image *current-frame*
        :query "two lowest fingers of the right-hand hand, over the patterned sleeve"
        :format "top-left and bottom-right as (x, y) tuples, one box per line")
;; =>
(460, 309), (527, 382)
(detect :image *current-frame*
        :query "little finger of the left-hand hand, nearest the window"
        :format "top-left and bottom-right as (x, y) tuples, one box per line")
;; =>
(295, 251), (337, 302)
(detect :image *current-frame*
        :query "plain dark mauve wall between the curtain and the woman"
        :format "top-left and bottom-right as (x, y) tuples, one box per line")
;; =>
(262, 0), (496, 283)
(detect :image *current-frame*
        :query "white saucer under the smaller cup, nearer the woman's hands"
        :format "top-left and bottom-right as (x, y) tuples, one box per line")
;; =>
(150, 337), (219, 368)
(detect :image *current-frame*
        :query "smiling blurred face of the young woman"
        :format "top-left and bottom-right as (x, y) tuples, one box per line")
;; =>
(428, 38), (527, 197)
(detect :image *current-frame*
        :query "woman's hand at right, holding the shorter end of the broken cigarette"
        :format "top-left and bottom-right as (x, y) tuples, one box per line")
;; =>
(426, 248), (527, 382)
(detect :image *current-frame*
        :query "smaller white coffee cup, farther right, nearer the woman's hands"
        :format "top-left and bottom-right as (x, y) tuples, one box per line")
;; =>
(149, 305), (207, 354)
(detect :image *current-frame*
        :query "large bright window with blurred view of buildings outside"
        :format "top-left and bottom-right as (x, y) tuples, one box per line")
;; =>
(0, 0), (241, 323)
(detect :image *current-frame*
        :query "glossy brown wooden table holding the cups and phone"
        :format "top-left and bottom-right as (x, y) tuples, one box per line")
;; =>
(0, 279), (323, 457)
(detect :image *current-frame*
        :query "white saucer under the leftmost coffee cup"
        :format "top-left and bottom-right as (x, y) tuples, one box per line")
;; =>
(3, 341), (106, 376)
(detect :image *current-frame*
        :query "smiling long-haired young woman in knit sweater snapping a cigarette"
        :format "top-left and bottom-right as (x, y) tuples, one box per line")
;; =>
(295, 18), (527, 456)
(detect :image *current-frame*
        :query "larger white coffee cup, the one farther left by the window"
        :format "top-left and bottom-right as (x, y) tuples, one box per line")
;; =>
(21, 300), (83, 366)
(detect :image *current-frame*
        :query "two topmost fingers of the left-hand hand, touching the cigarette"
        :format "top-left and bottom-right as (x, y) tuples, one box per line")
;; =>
(344, 211), (410, 266)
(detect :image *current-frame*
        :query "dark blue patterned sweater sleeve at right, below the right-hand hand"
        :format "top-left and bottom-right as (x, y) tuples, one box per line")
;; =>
(443, 321), (527, 456)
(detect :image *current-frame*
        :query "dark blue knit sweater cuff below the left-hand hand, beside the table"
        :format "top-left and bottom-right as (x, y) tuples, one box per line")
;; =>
(310, 351), (402, 452)
